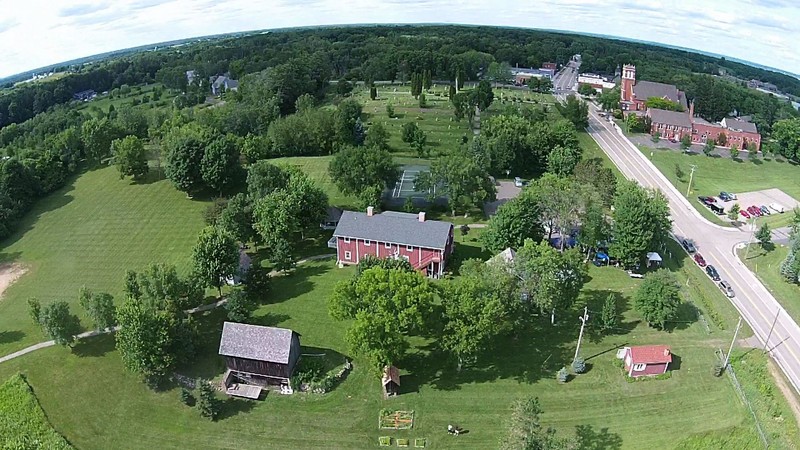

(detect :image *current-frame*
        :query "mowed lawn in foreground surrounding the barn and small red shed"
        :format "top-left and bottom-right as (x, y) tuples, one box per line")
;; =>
(0, 253), (768, 449)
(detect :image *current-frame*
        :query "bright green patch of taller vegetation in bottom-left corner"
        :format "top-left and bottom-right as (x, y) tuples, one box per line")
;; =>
(0, 375), (72, 450)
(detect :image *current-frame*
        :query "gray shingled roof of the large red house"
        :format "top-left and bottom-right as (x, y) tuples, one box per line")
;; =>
(333, 211), (453, 249)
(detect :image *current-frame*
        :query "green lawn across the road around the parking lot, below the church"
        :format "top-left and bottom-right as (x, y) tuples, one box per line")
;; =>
(641, 149), (800, 228)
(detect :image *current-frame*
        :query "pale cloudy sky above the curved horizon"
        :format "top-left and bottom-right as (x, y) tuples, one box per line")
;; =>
(0, 0), (800, 77)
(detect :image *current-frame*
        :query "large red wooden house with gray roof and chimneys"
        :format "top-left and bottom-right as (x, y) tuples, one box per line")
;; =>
(328, 207), (453, 278)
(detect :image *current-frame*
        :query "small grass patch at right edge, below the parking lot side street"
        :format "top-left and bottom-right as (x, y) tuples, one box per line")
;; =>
(739, 244), (800, 321)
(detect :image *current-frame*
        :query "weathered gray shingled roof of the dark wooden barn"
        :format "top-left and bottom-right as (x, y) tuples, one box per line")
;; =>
(219, 322), (292, 364)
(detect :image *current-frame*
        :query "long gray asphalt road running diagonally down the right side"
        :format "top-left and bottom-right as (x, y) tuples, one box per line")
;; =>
(587, 97), (800, 392)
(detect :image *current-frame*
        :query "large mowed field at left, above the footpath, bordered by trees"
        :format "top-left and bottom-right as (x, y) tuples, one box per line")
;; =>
(0, 167), (206, 355)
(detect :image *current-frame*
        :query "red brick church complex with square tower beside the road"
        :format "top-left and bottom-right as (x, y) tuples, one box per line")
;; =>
(620, 65), (761, 150)
